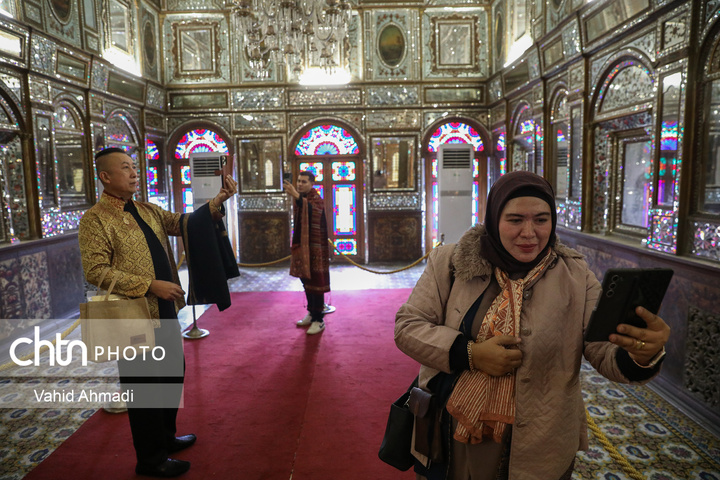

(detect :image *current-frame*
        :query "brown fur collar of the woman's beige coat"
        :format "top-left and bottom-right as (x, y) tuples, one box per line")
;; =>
(452, 224), (583, 282)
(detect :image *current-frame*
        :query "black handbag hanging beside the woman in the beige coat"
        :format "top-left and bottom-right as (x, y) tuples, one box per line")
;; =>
(378, 378), (418, 472)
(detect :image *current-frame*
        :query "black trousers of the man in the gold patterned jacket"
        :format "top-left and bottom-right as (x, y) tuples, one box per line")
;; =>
(118, 319), (185, 466)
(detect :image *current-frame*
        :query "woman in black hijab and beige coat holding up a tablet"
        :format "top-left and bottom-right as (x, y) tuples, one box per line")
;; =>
(395, 171), (670, 480)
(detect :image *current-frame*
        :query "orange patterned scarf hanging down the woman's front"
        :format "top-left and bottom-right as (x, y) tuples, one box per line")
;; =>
(447, 252), (551, 443)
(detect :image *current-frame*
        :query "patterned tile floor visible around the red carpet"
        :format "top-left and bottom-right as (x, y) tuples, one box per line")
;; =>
(0, 263), (720, 480)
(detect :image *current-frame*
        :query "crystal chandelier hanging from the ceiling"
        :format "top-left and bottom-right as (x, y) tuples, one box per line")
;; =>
(229, 0), (351, 78)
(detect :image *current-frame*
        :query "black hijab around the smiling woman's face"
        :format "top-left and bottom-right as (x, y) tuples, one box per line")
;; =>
(480, 171), (557, 274)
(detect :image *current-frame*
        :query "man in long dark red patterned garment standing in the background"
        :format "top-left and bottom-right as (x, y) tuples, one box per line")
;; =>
(283, 171), (330, 335)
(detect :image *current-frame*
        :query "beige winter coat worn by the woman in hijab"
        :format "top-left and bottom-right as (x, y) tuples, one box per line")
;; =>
(395, 226), (660, 480)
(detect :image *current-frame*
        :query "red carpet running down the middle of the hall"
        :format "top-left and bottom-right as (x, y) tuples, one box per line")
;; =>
(25, 289), (417, 480)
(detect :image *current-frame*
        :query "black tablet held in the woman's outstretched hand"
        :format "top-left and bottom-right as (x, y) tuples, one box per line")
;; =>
(585, 268), (673, 342)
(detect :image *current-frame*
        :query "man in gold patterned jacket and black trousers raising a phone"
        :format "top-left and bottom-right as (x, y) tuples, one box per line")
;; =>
(79, 148), (237, 477)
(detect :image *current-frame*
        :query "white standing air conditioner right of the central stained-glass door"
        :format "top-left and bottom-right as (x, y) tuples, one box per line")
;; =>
(438, 143), (473, 244)
